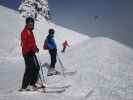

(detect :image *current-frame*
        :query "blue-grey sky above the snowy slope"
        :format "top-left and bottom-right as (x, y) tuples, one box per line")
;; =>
(0, 0), (133, 47)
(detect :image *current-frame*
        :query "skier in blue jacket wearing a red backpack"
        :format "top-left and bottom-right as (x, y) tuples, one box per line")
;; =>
(43, 29), (58, 76)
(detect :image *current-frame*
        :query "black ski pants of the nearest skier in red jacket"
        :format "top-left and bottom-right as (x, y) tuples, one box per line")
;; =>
(22, 53), (40, 89)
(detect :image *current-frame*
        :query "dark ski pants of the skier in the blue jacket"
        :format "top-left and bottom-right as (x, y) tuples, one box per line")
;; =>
(49, 48), (57, 68)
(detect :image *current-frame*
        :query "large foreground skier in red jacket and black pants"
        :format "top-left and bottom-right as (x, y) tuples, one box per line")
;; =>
(19, 17), (40, 91)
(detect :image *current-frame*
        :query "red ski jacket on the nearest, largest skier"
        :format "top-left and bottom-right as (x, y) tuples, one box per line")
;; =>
(21, 26), (37, 55)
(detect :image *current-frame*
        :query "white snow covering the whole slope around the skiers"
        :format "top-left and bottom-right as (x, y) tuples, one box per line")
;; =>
(0, 6), (133, 100)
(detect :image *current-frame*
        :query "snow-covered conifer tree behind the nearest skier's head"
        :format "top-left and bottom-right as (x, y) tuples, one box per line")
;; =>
(19, 0), (50, 19)
